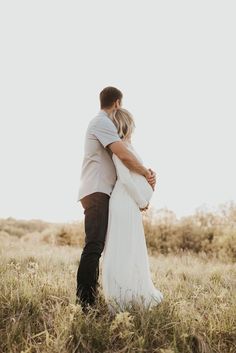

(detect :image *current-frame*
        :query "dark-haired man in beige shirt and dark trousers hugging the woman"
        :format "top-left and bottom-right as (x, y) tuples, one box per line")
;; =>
(76, 87), (156, 311)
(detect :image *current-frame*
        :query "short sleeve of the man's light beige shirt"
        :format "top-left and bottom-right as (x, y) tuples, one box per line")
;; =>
(93, 118), (121, 148)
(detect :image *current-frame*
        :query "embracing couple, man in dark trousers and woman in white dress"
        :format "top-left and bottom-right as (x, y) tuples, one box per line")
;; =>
(76, 87), (163, 313)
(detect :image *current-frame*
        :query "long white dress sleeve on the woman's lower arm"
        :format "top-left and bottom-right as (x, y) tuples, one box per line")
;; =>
(112, 154), (148, 208)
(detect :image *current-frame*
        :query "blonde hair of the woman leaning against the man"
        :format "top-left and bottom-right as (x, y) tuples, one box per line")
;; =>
(112, 108), (135, 139)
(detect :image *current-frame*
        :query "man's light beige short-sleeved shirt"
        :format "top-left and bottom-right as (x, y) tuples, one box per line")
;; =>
(77, 110), (121, 201)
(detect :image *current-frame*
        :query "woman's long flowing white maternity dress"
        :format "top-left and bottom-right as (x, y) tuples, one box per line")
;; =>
(101, 144), (163, 312)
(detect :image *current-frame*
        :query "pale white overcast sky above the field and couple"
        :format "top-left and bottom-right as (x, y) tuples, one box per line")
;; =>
(0, 0), (236, 222)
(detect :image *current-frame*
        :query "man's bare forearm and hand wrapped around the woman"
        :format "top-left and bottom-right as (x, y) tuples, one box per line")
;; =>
(107, 141), (156, 189)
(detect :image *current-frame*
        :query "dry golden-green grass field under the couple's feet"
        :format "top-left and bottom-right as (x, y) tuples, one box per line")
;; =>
(0, 214), (236, 353)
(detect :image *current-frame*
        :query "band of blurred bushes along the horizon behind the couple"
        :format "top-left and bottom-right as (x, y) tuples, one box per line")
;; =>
(0, 202), (236, 261)
